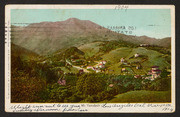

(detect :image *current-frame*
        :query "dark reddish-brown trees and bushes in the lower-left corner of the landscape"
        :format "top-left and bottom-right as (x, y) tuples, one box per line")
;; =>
(11, 56), (58, 102)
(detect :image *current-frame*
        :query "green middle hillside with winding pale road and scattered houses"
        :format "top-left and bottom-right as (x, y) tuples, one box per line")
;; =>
(38, 41), (171, 75)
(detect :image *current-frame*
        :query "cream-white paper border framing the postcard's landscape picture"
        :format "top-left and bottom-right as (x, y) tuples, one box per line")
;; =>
(5, 4), (175, 113)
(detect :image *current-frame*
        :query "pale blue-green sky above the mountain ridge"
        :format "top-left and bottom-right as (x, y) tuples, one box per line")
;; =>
(11, 9), (171, 39)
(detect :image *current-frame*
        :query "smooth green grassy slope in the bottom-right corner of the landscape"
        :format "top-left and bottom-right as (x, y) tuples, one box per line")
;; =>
(108, 90), (171, 103)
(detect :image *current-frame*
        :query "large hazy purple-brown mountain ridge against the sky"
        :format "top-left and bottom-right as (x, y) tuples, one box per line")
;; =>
(11, 18), (171, 55)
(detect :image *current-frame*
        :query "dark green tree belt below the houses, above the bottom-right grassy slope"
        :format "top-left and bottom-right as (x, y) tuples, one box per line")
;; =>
(35, 73), (170, 102)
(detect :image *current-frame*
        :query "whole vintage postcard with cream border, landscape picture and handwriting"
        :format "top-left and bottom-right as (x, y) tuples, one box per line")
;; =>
(5, 5), (175, 113)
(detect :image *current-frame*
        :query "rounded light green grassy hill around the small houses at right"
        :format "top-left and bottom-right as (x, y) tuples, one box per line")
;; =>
(102, 47), (170, 74)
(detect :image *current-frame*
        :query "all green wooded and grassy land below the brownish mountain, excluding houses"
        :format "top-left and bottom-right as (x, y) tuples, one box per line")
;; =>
(11, 41), (171, 103)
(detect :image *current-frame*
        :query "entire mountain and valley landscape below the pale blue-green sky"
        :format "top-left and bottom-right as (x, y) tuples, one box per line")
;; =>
(11, 18), (171, 103)
